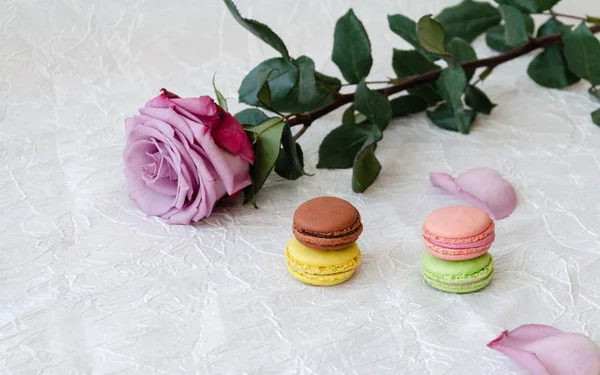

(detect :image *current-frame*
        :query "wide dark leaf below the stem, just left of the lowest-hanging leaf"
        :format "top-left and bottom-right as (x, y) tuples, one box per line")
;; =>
(317, 124), (382, 169)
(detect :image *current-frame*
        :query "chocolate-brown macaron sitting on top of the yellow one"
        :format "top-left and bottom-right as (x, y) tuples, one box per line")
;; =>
(292, 197), (363, 250)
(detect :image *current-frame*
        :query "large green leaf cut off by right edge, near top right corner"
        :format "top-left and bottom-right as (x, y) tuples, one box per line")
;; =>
(564, 22), (600, 86)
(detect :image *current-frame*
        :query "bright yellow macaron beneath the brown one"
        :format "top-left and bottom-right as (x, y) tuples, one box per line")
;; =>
(285, 238), (361, 285)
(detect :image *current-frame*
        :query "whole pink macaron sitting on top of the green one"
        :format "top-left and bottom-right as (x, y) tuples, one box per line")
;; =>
(423, 206), (495, 260)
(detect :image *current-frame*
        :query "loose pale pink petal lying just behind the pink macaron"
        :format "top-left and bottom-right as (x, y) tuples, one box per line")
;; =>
(429, 168), (517, 219)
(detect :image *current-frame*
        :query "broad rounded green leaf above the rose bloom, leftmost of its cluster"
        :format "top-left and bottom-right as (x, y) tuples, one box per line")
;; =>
(239, 57), (298, 109)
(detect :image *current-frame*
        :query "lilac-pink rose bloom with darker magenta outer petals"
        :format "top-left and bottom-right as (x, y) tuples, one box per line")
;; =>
(123, 89), (254, 224)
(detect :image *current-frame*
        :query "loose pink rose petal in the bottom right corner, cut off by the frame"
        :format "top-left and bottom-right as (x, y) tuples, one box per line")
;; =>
(487, 324), (600, 375)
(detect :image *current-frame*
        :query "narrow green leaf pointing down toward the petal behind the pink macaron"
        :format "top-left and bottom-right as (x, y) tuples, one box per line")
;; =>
(437, 61), (471, 134)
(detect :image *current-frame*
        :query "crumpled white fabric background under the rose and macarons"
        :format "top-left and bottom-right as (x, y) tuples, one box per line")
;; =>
(0, 0), (600, 375)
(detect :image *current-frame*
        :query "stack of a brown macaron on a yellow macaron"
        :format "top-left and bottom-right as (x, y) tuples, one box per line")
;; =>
(285, 197), (363, 285)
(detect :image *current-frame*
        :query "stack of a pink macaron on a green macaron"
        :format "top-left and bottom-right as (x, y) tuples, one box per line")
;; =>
(421, 206), (495, 293)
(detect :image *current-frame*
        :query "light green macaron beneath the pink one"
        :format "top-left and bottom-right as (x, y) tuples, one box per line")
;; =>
(421, 252), (494, 293)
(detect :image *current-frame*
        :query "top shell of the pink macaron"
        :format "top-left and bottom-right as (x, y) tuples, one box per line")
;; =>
(423, 206), (494, 239)
